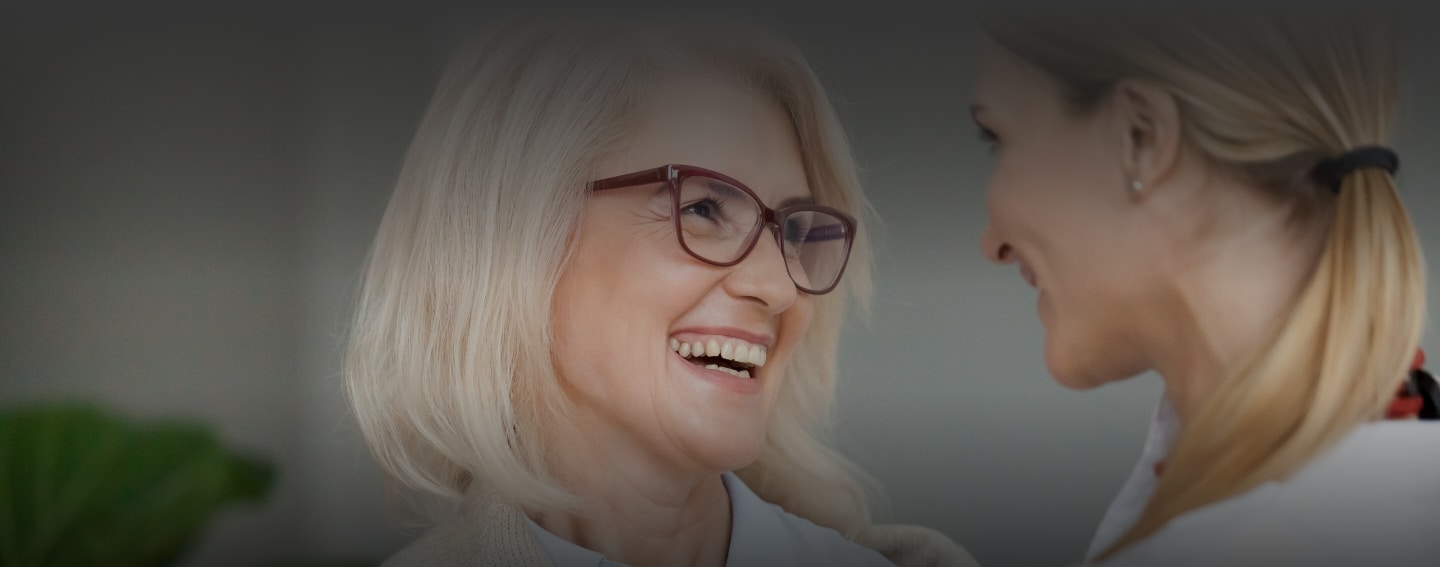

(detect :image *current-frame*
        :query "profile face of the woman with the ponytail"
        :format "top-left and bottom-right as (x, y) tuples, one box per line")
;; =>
(973, 40), (1156, 389)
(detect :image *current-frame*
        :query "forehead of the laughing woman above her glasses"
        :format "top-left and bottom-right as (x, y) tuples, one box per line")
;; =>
(602, 72), (809, 204)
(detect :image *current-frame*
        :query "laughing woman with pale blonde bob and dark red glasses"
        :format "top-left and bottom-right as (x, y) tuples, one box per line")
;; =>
(347, 12), (968, 566)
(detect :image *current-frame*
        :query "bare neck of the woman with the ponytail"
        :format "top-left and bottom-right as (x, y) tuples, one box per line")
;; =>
(1152, 183), (1328, 425)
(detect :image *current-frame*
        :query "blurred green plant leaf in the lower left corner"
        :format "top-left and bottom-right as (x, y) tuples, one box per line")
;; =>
(0, 404), (275, 567)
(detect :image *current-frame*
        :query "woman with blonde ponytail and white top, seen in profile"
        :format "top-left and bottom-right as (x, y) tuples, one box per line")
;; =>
(973, 7), (1440, 566)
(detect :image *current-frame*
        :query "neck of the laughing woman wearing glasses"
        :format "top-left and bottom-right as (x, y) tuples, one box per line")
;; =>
(530, 420), (730, 567)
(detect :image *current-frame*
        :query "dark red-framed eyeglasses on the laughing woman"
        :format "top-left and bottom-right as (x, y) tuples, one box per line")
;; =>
(588, 164), (855, 295)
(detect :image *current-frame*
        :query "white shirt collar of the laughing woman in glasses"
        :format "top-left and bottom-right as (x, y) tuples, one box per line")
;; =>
(526, 472), (890, 567)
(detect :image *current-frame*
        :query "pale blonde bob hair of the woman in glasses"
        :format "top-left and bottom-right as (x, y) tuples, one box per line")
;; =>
(344, 12), (870, 534)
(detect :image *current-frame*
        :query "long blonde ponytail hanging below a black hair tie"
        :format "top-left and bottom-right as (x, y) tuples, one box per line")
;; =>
(1100, 170), (1426, 558)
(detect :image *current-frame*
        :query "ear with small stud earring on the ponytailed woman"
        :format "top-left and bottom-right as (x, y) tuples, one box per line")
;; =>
(1112, 79), (1181, 187)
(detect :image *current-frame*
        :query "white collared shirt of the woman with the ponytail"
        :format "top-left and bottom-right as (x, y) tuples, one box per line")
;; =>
(1089, 402), (1440, 567)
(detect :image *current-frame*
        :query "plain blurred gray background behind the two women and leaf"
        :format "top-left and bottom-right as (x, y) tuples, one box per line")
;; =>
(0, 6), (1440, 566)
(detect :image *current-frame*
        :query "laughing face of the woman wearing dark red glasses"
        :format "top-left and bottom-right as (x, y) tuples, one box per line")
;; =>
(554, 75), (812, 471)
